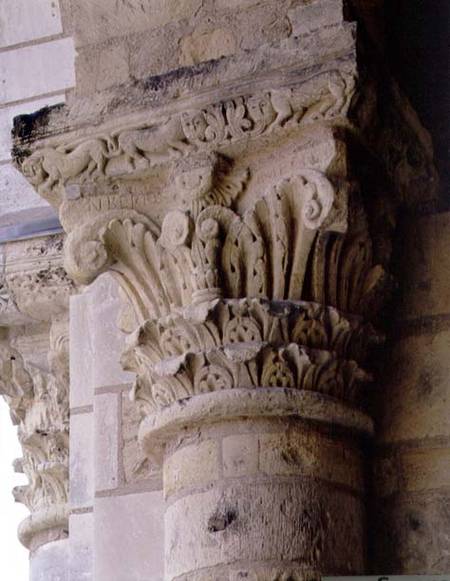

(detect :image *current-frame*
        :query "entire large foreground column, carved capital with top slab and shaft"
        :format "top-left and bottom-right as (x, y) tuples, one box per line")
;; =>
(9, 20), (435, 581)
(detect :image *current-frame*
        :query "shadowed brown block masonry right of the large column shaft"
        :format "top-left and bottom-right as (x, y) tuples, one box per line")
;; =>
(373, 213), (450, 574)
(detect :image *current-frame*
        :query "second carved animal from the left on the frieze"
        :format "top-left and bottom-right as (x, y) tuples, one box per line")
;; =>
(118, 117), (189, 169)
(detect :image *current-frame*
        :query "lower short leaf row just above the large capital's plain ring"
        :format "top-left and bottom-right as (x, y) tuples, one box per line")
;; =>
(124, 336), (370, 415)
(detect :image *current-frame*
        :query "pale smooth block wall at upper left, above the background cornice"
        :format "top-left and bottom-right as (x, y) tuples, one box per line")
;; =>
(0, 0), (75, 226)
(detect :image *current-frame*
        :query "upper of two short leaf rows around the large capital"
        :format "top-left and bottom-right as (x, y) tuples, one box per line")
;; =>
(124, 299), (379, 364)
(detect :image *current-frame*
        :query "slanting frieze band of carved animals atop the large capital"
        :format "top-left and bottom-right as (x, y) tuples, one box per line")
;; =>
(22, 71), (355, 201)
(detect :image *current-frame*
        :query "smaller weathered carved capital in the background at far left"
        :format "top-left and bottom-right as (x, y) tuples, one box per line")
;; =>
(0, 235), (75, 550)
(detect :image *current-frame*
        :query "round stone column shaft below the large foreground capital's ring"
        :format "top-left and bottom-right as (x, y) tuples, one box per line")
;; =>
(164, 420), (364, 579)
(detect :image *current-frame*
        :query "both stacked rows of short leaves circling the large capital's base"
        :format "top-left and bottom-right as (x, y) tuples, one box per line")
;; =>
(122, 299), (378, 415)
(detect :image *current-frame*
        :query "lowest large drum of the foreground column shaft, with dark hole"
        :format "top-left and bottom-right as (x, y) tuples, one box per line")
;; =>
(165, 480), (364, 579)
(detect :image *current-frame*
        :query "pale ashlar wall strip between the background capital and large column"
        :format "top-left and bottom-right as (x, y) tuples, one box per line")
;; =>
(70, 276), (164, 581)
